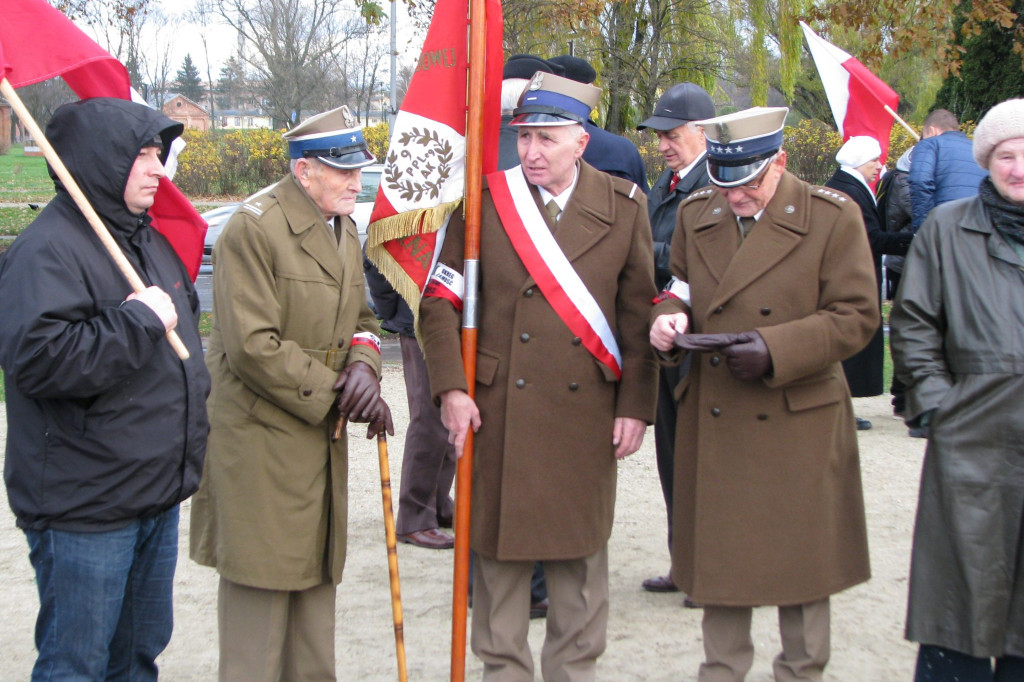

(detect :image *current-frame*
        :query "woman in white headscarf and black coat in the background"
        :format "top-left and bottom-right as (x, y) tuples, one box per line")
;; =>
(825, 135), (913, 430)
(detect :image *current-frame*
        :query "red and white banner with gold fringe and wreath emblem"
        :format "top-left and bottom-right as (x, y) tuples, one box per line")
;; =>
(367, 0), (503, 311)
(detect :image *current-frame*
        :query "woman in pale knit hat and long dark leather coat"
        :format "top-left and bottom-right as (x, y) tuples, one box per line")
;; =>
(891, 99), (1024, 682)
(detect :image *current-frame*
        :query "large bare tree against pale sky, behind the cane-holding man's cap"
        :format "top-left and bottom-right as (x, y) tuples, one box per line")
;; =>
(215, 0), (362, 127)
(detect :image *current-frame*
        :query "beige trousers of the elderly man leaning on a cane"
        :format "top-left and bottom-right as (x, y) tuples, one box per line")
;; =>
(217, 578), (337, 682)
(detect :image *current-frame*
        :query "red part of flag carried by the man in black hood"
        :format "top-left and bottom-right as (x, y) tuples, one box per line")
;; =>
(0, 0), (206, 280)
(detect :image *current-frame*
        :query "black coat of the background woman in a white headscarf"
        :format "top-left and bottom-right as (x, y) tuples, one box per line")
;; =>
(825, 168), (912, 397)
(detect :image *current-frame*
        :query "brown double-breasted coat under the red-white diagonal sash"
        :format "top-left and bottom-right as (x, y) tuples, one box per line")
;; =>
(420, 162), (657, 561)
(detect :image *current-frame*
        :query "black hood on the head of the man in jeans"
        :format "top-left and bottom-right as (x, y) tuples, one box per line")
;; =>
(46, 97), (184, 235)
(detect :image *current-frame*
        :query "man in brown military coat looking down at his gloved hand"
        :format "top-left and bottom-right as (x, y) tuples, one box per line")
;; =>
(650, 108), (880, 682)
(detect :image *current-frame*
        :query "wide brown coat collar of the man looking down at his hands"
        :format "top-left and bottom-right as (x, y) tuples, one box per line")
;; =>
(693, 172), (810, 309)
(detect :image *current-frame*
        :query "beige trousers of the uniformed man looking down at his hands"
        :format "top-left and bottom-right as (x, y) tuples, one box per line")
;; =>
(697, 598), (831, 682)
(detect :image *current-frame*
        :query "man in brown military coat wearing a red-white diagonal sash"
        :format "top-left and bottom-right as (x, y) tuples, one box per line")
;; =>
(420, 74), (657, 682)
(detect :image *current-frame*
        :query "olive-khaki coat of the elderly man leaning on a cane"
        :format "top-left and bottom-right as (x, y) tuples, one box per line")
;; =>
(190, 174), (380, 590)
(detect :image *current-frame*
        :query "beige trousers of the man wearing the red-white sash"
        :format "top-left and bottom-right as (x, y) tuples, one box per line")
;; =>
(471, 546), (608, 682)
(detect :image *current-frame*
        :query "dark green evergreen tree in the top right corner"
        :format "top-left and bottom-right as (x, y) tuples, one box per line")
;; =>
(935, 0), (1024, 122)
